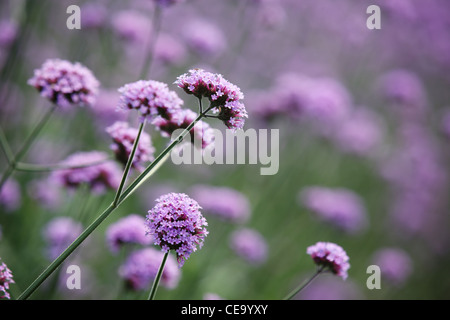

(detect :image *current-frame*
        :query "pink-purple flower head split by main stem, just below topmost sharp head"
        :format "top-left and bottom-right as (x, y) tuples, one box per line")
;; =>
(152, 109), (214, 149)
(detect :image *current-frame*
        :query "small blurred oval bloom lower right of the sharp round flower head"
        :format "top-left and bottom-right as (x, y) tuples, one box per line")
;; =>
(230, 228), (268, 265)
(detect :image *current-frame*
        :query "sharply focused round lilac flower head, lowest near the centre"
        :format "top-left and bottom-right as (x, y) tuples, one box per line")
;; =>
(146, 193), (208, 268)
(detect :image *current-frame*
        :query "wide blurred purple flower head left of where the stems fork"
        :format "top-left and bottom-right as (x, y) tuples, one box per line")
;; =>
(50, 151), (122, 193)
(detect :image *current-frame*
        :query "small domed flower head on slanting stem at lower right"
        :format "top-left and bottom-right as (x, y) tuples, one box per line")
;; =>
(306, 242), (350, 280)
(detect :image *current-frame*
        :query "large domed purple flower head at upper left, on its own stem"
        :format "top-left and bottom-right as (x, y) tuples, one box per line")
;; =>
(28, 59), (100, 107)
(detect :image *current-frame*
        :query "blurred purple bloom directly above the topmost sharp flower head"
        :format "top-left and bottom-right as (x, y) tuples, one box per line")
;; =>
(183, 19), (226, 57)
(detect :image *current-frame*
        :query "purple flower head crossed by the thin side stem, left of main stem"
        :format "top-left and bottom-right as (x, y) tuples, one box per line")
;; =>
(106, 121), (155, 170)
